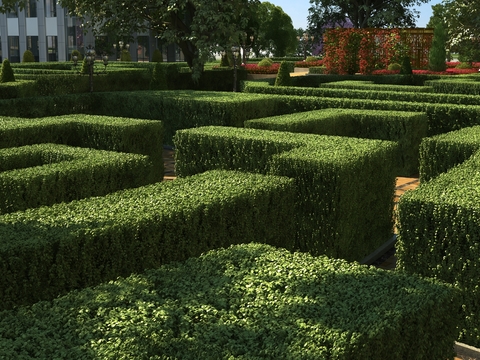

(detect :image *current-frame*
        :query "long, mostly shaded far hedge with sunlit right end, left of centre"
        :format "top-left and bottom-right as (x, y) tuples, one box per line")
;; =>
(0, 90), (280, 145)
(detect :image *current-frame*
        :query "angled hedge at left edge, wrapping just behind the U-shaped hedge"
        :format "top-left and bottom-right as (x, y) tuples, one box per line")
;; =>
(0, 115), (164, 181)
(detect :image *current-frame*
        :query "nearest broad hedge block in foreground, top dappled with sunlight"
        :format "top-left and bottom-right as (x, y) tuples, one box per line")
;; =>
(0, 244), (457, 360)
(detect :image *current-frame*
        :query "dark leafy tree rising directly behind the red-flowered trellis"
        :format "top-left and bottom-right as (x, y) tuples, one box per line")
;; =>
(308, 0), (429, 41)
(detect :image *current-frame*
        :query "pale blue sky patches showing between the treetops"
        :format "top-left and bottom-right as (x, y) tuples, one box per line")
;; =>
(262, 0), (441, 29)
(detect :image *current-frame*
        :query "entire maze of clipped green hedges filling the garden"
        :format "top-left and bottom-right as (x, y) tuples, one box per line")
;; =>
(0, 74), (480, 360)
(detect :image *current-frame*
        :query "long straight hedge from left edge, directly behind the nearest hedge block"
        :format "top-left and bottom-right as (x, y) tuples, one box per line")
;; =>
(0, 171), (294, 308)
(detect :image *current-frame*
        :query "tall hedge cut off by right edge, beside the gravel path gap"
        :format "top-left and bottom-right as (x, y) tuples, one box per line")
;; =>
(397, 152), (480, 347)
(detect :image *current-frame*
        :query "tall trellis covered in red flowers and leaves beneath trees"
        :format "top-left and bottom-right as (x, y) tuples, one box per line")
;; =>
(324, 28), (433, 74)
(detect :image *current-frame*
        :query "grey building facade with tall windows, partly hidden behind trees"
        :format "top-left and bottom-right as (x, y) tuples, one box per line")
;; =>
(0, 0), (183, 63)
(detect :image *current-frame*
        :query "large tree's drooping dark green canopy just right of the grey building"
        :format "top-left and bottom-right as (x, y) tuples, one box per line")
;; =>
(0, 0), (259, 75)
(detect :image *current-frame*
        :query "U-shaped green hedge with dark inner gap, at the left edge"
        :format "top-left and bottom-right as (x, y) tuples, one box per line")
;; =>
(0, 144), (158, 214)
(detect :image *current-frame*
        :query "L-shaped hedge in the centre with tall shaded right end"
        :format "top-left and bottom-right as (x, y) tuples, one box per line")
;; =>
(174, 126), (397, 260)
